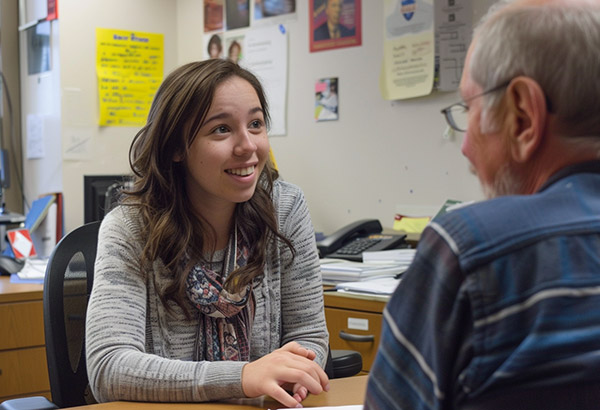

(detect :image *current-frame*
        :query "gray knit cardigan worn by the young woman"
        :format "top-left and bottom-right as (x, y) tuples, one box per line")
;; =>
(86, 181), (329, 402)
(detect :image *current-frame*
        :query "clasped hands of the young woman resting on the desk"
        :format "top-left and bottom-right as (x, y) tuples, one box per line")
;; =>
(242, 342), (329, 407)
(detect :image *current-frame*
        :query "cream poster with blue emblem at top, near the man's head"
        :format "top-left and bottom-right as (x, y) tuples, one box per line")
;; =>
(379, 0), (435, 100)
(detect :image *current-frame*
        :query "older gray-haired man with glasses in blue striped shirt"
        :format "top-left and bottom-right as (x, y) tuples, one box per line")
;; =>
(365, 0), (600, 410)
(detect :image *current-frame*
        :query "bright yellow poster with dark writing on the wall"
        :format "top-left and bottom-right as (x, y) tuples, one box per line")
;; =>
(96, 28), (164, 127)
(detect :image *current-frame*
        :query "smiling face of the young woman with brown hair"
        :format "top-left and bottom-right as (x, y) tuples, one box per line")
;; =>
(184, 77), (269, 215)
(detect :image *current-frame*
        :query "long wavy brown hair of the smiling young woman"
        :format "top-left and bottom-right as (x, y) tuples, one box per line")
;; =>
(123, 59), (295, 314)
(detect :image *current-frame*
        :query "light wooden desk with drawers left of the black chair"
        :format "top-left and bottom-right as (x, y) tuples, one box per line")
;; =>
(0, 276), (50, 402)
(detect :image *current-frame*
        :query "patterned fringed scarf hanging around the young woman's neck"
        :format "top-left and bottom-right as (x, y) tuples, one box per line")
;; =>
(186, 227), (254, 361)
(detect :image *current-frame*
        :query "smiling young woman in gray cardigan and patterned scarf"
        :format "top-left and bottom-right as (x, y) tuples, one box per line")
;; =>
(86, 59), (329, 407)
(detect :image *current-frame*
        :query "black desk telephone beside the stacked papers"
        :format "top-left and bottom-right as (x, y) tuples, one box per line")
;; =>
(317, 219), (407, 262)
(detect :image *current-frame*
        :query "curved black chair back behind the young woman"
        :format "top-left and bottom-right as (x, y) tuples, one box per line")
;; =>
(44, 221), (100, 408)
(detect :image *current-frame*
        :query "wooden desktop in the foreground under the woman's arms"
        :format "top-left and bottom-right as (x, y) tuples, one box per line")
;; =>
(65, 376), (367, 410)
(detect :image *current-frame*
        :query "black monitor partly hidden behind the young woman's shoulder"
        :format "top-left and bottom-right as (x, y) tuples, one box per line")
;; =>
(83, 175), (131, 223)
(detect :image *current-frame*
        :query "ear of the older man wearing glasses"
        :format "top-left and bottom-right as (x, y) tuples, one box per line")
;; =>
(506, 76), (547, 163)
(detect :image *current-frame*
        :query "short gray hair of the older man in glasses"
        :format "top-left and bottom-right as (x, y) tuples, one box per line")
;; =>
(466, 0), (600, 136)
